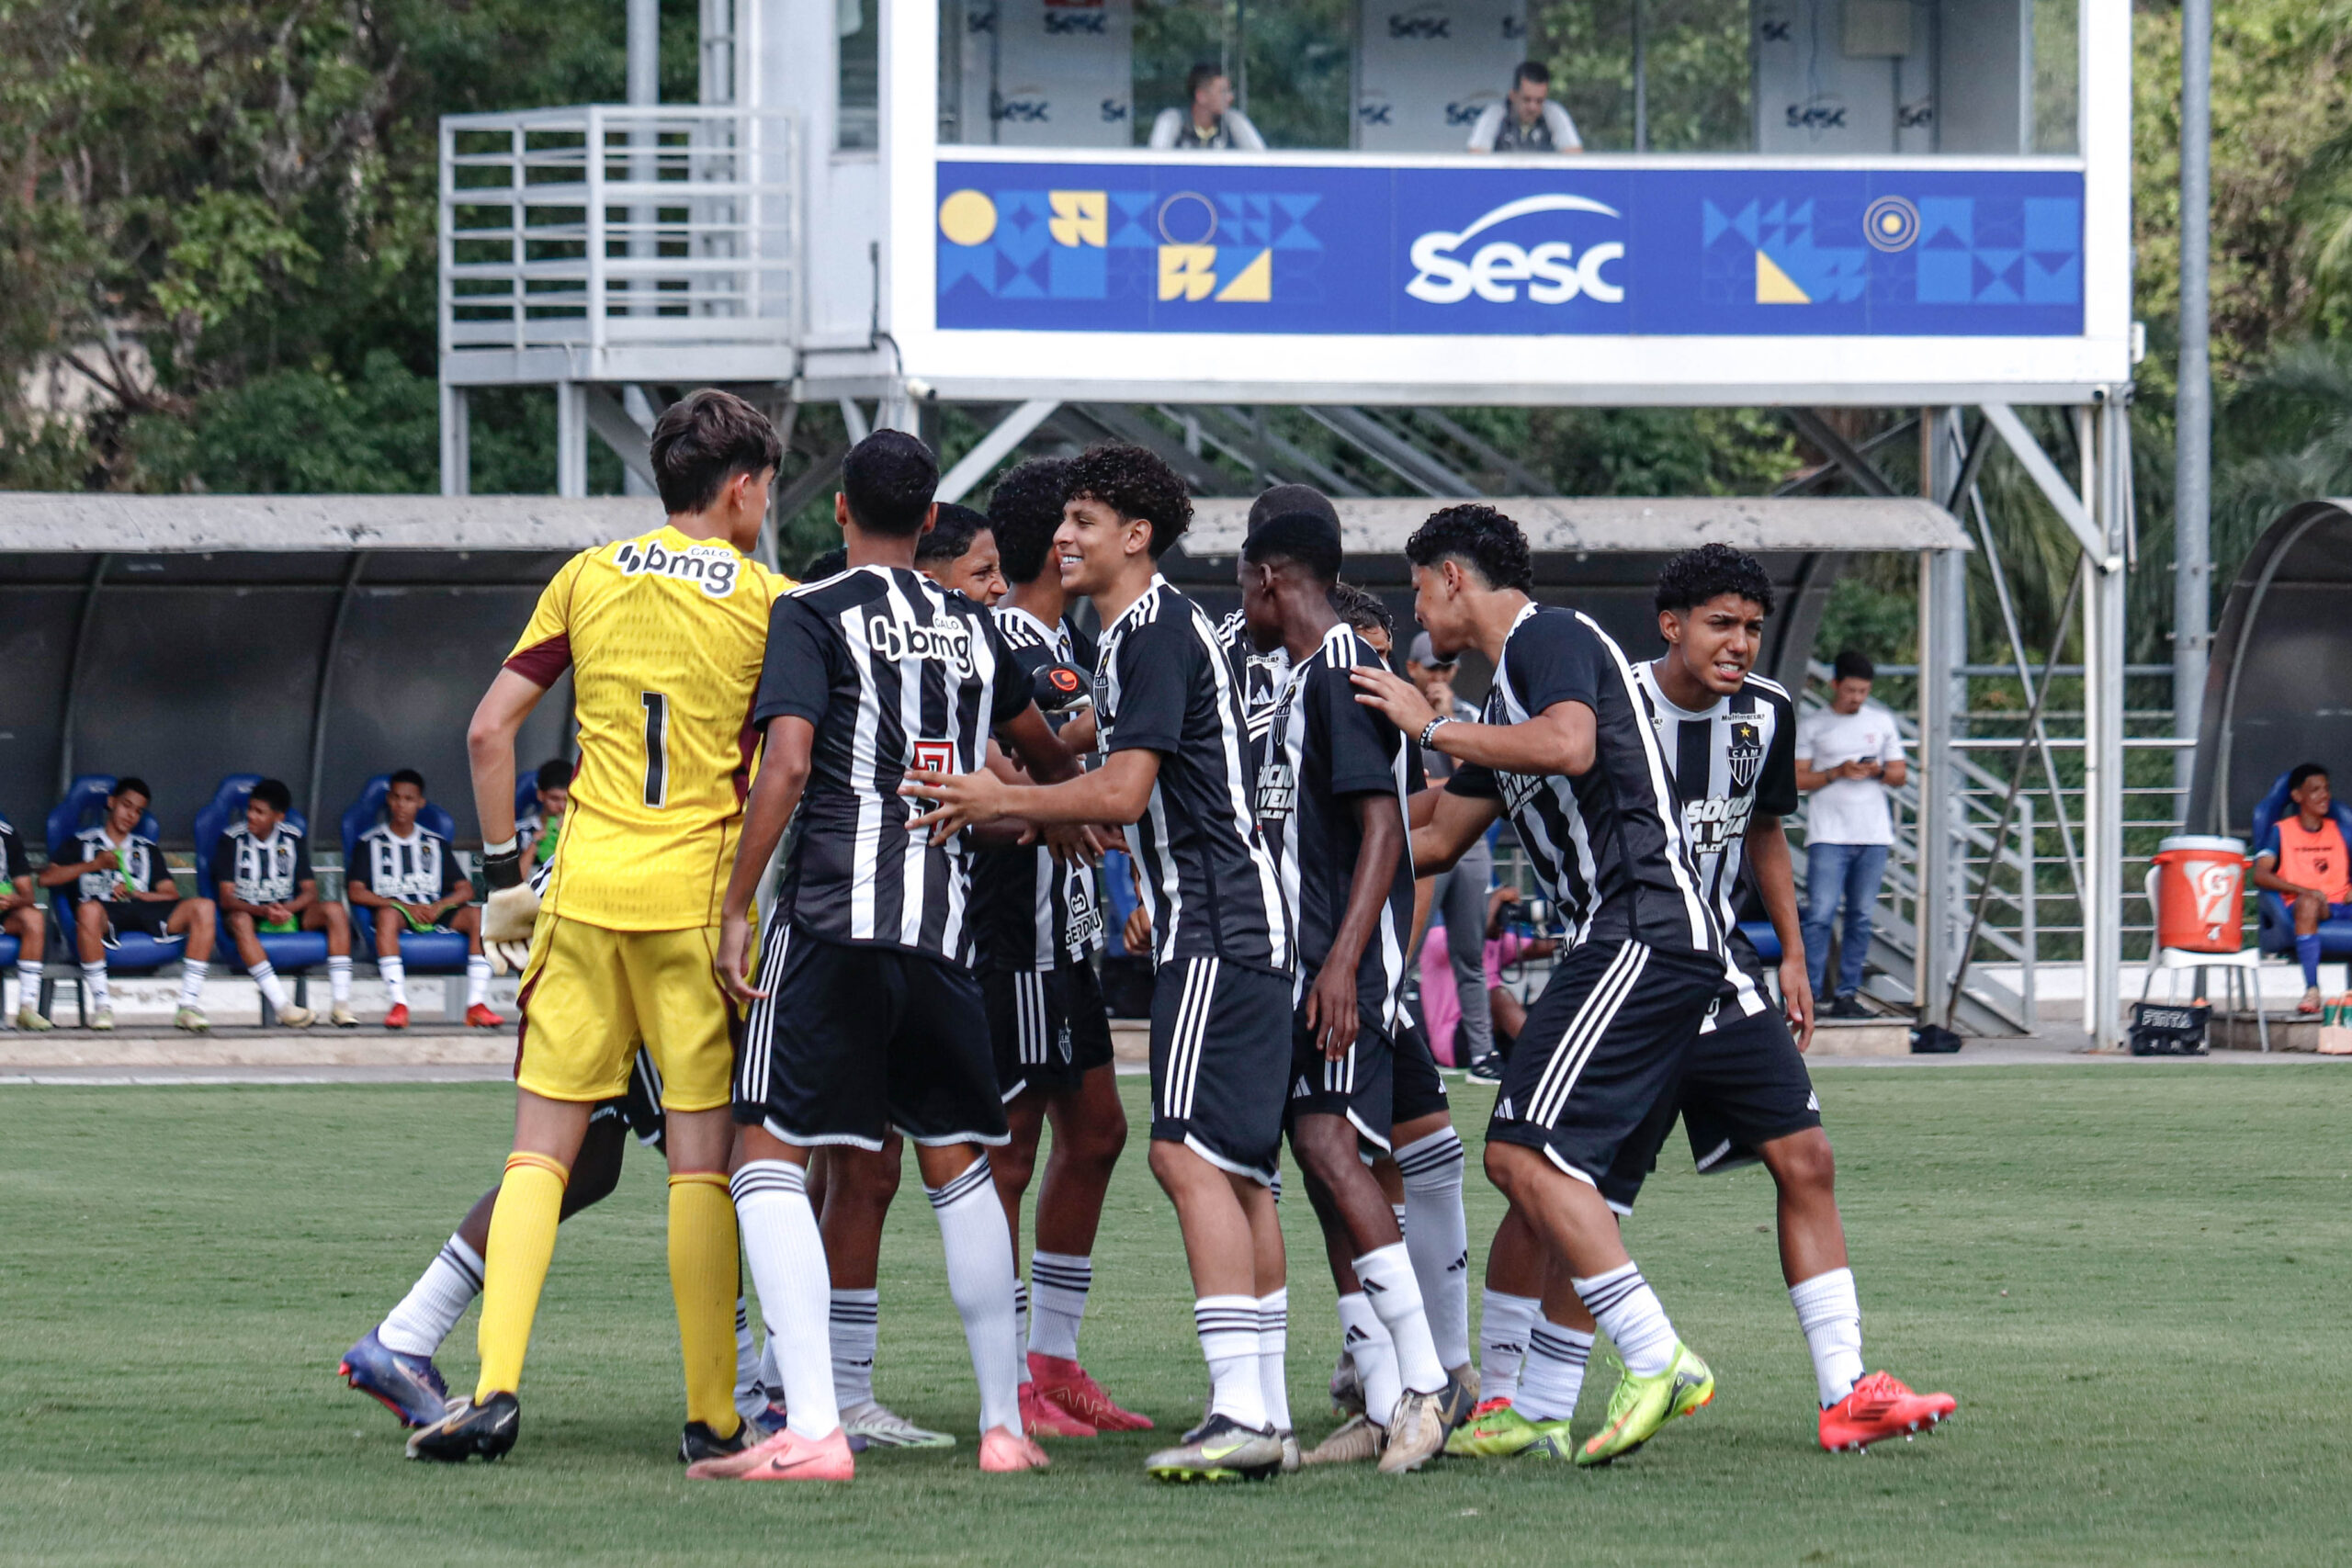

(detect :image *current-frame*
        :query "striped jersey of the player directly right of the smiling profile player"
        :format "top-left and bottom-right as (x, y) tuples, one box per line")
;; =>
(1251, 623), (1420, 1030)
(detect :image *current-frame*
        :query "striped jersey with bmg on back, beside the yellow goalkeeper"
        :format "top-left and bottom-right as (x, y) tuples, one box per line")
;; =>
(752, 567), (1030, 964)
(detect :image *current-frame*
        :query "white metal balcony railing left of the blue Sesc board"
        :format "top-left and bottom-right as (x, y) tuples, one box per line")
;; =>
(440, 104), (799, 353)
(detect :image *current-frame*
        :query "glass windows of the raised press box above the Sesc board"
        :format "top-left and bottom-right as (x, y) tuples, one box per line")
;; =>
(908, 0), (2079, 157)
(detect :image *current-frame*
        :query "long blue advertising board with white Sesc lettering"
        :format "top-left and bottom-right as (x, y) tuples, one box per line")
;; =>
(933, 157), (2084, 339)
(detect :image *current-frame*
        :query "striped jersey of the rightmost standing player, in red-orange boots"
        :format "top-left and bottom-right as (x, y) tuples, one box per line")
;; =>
(1634, 660), (1797, 1013)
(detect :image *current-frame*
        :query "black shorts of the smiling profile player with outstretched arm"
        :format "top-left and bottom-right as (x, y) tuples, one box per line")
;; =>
(1152, 959), (1291, 1187)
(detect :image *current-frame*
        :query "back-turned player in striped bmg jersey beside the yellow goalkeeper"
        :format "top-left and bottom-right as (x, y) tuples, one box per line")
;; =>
(687, 430), (1077, 1481)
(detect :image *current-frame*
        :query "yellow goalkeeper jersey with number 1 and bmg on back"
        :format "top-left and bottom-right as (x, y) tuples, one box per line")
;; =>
(505, 525), (793, 931)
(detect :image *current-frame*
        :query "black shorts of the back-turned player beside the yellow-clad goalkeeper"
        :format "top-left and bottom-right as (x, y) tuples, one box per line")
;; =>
(734, 921), (1007, 1149)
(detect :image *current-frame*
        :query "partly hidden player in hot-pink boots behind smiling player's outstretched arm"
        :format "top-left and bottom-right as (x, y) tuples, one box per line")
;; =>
(973, 458), (1152, 1437)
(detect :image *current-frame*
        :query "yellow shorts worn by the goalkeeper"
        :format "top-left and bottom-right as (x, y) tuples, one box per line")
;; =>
(515, 915), (734, 1110)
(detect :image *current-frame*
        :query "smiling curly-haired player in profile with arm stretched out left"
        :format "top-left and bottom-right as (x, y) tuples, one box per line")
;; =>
(906, 446), (1296, 1481)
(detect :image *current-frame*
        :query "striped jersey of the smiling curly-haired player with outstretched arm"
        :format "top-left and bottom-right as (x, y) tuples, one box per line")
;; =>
(1093, 576), (1291, 974)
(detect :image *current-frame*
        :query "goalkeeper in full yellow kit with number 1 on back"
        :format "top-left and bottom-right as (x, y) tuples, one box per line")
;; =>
(409, 390), (781, 1460)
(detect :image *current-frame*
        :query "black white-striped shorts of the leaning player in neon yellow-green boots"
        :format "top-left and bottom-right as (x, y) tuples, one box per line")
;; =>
(1487, 942), (1724, 1213)
